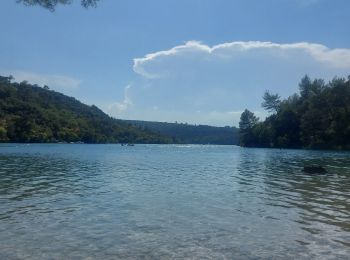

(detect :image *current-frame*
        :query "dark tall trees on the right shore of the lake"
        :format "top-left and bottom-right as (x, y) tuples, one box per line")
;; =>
(239, 76), (350, 150)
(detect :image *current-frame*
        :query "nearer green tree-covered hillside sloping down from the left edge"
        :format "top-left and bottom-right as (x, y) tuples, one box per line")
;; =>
(0, 76), (171, 143)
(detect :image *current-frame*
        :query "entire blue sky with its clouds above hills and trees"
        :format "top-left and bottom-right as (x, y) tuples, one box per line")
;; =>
(0, 0), (350, 126)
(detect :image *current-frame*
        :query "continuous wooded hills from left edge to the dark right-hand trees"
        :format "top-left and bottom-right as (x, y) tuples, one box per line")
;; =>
(0, 76), (238, 144)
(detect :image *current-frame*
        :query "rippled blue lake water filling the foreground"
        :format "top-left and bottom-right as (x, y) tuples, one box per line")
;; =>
(0, 144), (350, 259)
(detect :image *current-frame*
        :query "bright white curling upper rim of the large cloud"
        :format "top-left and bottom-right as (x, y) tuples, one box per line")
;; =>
(133, 41), (350, 79)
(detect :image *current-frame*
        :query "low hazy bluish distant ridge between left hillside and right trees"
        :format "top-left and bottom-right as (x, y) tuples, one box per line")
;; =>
(126, 120), (239, 145)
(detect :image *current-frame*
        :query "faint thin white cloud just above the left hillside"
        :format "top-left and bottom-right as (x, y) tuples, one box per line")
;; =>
(1, 70), (81, 89)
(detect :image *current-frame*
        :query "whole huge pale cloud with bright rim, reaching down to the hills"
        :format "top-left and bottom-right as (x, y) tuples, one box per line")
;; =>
(129, 41), (350, 125)
